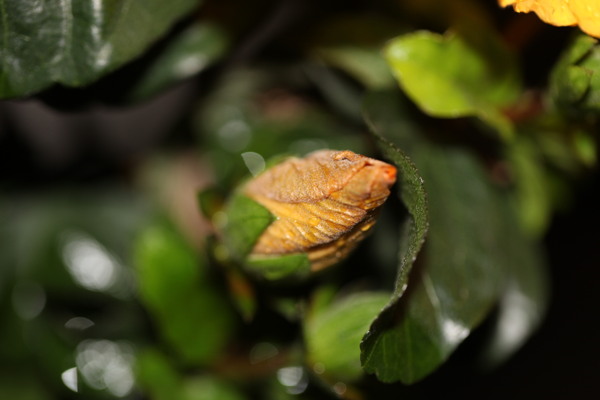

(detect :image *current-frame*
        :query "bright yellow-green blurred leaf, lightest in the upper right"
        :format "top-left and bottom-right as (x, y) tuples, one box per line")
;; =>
(385, 31), (519, 136)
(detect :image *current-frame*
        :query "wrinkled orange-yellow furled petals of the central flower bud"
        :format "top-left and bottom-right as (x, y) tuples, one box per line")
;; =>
(244, 150), (396, 271)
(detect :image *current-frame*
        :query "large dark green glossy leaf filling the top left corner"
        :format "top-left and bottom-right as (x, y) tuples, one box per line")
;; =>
(0, 0), (198, 98)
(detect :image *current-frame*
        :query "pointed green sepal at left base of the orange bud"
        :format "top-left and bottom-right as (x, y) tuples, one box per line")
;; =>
(223, 192), (275, 262)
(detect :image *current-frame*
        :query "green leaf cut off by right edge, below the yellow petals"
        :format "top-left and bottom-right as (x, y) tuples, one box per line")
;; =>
(550, 35), (600, 116)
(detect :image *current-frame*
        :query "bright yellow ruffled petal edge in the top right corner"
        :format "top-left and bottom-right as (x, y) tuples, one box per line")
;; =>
(498, 0), (600, 37)
